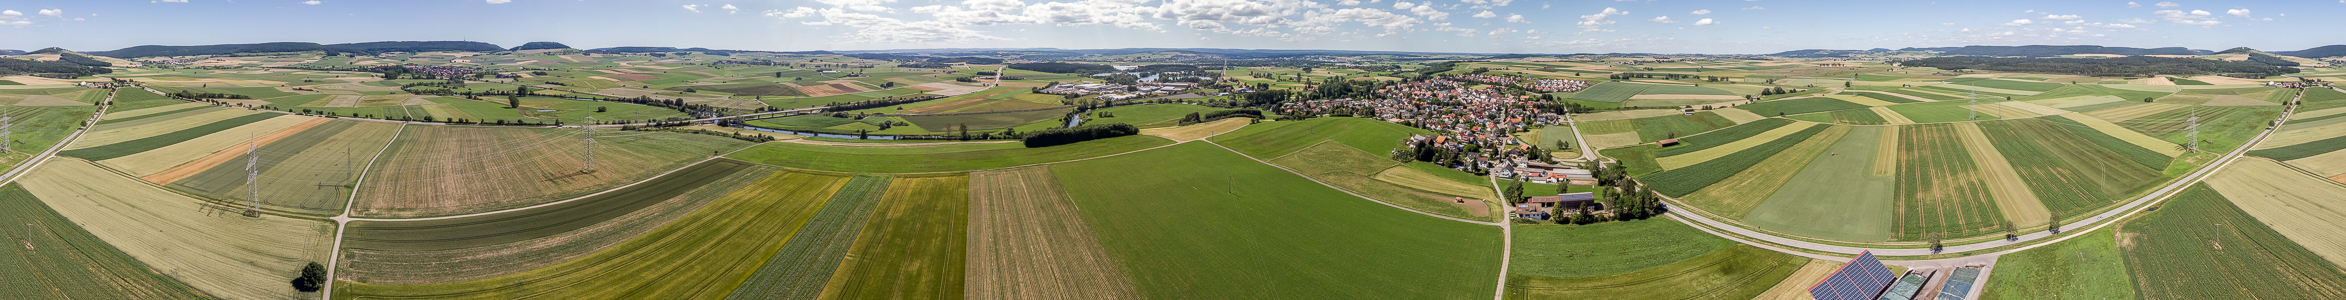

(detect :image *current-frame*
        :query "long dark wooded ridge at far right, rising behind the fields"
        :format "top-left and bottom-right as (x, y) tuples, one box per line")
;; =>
(1900, 56), (2297, 77)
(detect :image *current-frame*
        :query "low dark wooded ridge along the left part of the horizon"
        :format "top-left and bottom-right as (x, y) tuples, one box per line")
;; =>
(89, 42), (504, 59)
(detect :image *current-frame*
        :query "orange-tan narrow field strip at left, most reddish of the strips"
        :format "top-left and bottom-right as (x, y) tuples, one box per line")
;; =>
(99, 115), (321, 176)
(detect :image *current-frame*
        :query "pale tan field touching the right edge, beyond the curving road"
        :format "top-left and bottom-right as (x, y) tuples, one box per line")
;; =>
(2208, 157), (2346, 265)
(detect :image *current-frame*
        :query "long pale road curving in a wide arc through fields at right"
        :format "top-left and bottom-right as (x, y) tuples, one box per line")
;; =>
(1642, 88), (2294, 263)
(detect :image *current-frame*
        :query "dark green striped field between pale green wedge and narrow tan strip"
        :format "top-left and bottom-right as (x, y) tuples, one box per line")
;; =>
(1891, 124), (2003, 241)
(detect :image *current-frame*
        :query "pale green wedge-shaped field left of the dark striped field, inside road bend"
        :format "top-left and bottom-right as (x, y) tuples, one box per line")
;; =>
(1741, 127), (1898, 241)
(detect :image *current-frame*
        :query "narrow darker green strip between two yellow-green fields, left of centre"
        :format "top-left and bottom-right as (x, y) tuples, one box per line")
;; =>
(725, 173), (891, 300)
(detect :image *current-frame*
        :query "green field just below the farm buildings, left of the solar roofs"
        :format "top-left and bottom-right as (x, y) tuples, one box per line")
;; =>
(1506, 218), (1734, 277)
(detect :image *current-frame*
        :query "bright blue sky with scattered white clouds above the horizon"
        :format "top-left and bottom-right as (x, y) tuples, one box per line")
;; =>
(0, 0), (2346, 54)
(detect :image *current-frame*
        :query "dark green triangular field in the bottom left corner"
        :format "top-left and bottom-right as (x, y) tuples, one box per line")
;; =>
(0, 185), (202, 300)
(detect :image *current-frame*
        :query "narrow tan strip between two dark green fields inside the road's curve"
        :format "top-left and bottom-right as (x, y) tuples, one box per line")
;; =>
(1954, 122), (2053, 227)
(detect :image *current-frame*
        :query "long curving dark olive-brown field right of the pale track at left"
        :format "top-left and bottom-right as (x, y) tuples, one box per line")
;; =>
(335, 159), (772, 284)
